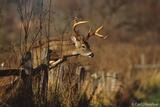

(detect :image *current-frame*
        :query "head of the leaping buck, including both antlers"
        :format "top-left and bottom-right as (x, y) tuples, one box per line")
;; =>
(71, 21), (107, 57)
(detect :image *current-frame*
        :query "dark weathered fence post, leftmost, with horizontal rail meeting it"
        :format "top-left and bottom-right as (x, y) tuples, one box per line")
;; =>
(21, 52), (33, 107)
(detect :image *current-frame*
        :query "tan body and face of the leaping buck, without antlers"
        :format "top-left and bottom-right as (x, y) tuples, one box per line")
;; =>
(31, 37), (94, 66)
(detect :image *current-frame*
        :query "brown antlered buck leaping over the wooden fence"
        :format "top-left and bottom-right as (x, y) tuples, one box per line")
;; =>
(32, 21), (106, 66)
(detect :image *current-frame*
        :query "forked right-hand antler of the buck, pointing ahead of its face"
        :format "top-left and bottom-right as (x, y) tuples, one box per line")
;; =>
(86, 26), (108, 40)
